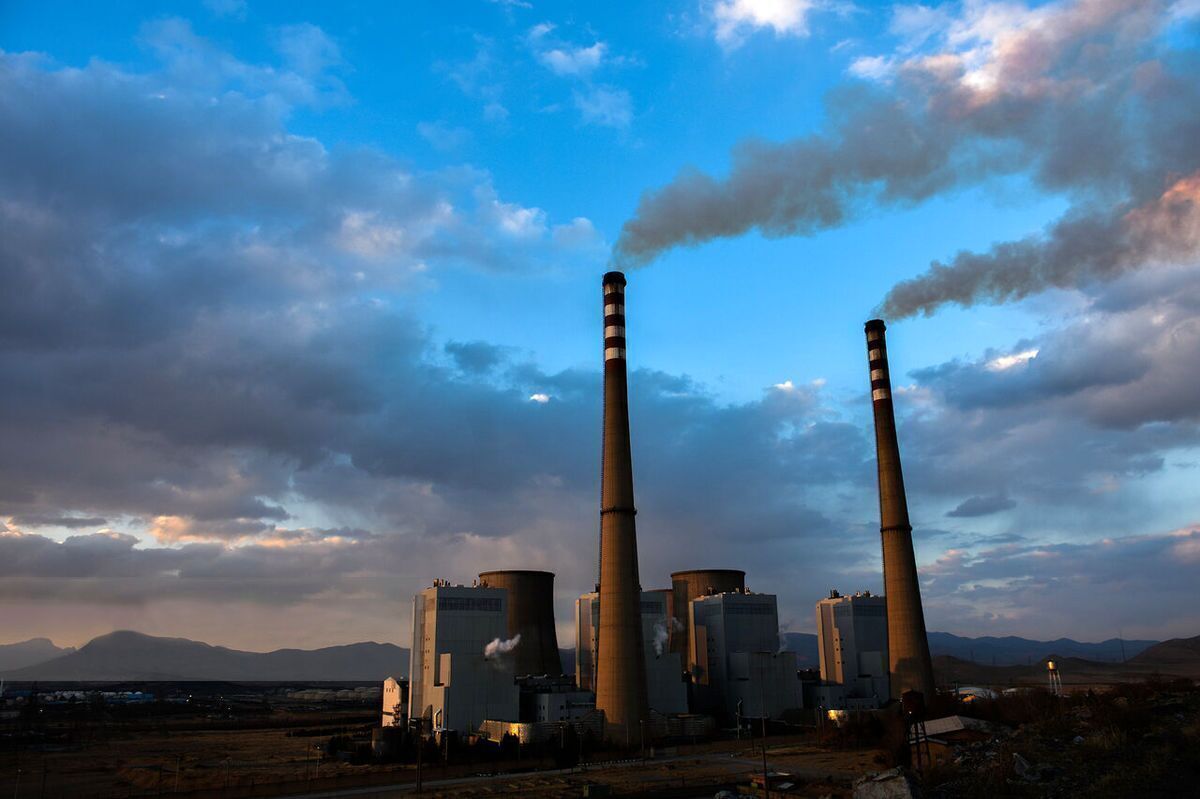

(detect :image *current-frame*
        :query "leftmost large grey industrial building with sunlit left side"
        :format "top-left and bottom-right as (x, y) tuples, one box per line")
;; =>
(408, 581), (520, 732)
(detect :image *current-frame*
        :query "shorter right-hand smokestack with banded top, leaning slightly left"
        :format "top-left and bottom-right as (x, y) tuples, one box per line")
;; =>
(866, 319), (934, 702)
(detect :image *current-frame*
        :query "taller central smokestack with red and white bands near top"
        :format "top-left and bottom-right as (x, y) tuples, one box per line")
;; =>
(596, 272), (649, 745)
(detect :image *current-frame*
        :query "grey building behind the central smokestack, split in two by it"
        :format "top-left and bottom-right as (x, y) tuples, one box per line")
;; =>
(575, 589), (688, 715)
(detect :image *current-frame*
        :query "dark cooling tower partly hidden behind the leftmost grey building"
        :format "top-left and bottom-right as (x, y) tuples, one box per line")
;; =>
(479, 570), (563, 675)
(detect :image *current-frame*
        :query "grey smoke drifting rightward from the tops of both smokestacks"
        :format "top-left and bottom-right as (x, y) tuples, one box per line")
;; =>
(612, 0), (1200, 317)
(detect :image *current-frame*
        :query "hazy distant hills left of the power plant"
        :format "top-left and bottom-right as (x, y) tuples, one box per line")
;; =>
(2, 631), (408, 681)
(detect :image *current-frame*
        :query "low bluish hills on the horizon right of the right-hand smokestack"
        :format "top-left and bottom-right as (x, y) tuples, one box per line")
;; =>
(929, 632), (1158, 666)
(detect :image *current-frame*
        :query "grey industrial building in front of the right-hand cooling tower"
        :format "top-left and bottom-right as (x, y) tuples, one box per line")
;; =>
(688, 591), (802, 720)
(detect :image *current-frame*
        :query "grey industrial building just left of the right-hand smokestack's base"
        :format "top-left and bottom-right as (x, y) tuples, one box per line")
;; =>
(816, 590), (890, 709)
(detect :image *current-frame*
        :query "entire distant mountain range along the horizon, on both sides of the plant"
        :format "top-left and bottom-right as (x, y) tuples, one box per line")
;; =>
(0, 631), (1180, 681)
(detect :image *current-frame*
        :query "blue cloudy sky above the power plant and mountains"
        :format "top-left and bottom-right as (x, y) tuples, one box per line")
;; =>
(0, 0), (1200, 650)
